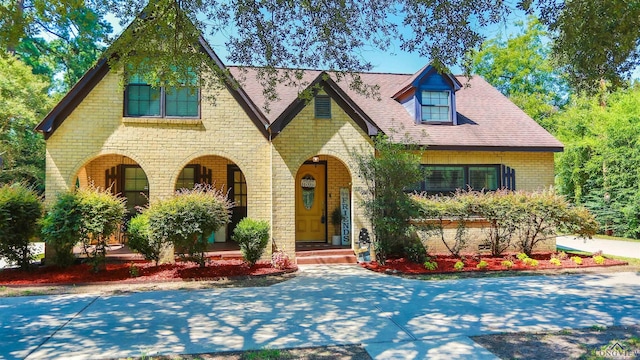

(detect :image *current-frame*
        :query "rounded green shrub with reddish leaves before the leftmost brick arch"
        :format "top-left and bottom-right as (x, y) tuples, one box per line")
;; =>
(42, 188), (126, 271)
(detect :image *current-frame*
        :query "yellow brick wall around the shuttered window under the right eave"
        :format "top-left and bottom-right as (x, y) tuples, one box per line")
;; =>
(422, 148), (554, 191)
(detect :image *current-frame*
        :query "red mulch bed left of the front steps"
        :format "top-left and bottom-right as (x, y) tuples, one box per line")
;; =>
(0, 260), (297, 285)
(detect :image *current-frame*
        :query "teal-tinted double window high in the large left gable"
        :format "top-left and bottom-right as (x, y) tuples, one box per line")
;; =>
(124, 69), (200, 117)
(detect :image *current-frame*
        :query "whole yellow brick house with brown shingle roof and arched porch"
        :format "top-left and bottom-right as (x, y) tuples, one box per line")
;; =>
(37, 34), (563, 253)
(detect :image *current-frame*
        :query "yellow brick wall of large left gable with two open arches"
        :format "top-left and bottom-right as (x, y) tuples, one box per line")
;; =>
(46, 73), (272, 256)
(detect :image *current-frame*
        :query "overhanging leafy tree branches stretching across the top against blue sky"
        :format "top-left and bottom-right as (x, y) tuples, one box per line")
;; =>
(0, 0), (640, 95)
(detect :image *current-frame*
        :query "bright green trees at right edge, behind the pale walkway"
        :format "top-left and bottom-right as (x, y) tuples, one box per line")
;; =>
(555, 84), (640, 239)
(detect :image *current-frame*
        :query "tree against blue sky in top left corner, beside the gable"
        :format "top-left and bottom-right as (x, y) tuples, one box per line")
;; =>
(0, 0), (112, 93)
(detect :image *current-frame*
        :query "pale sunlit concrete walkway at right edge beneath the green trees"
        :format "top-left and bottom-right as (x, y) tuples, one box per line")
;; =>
(556, 236), (640, 259)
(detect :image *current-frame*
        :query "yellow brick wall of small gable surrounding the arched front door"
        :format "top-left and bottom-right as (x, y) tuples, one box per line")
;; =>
(272, 94), (373, 255)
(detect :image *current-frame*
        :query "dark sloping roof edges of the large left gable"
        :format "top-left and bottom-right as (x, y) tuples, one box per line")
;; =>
(36, 35), (269, 139)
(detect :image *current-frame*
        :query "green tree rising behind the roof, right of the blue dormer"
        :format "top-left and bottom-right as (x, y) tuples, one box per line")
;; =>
(471, 17), (570, 131)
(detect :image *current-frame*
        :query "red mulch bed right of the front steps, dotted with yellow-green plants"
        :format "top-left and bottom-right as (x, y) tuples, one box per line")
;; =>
(360, 253), (627, 274)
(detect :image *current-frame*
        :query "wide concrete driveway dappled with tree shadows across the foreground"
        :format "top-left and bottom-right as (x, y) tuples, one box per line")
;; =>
(0, 265), (640, 359)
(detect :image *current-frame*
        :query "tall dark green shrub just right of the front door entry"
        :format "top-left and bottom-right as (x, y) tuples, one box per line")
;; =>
(351, 135), (422, 264)
